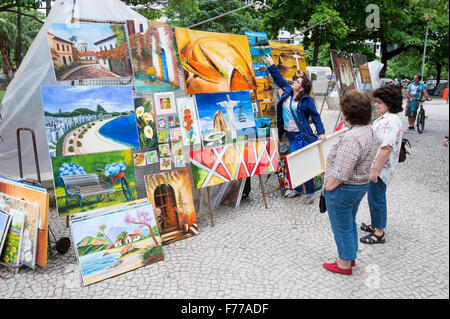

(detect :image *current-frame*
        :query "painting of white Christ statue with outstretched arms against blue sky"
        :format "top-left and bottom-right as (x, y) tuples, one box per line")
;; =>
(195, 91), (256, 146)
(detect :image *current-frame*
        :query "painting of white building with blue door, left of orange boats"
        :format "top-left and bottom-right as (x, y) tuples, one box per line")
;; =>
(127, 20), (180, 93)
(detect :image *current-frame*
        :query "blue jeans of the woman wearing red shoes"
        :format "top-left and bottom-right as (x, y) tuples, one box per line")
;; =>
(324, 184), (368, 261)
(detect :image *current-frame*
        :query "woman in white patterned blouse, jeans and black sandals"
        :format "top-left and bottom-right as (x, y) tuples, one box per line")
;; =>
(360, 85), (403, 244)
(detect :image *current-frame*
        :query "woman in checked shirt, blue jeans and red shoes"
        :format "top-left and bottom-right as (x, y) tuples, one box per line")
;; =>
(323, 90), (380, 275)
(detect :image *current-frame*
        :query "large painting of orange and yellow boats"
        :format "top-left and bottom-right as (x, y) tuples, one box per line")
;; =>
(175, 28), (256, 95)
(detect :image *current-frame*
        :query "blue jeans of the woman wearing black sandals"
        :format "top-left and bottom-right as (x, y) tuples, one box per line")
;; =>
(367, 177), (387, 229)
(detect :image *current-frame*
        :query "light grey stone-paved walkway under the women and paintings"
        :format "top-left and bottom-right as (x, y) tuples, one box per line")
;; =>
(0, 99), (449, 299)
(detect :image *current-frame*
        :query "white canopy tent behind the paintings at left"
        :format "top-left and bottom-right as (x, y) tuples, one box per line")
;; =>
(0, 0), (146, 180)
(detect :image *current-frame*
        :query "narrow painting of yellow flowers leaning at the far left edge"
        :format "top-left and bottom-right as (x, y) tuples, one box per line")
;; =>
(0, 210), (25, 274)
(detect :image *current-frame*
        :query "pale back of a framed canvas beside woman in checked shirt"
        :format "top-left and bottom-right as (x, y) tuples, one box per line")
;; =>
(285, 129), (347, 188)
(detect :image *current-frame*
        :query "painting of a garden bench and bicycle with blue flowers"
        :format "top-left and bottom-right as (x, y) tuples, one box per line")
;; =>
(52, 150), (137, 216)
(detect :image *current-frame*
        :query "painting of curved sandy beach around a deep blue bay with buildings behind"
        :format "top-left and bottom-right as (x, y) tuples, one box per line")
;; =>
(41, 86), (139, 157)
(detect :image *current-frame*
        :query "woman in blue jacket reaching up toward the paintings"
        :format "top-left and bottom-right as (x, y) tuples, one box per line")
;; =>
(265, 55), (325, 204)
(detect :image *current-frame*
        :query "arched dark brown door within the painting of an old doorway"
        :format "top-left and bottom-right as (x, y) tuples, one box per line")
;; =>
(153, 184), (180, 234)
